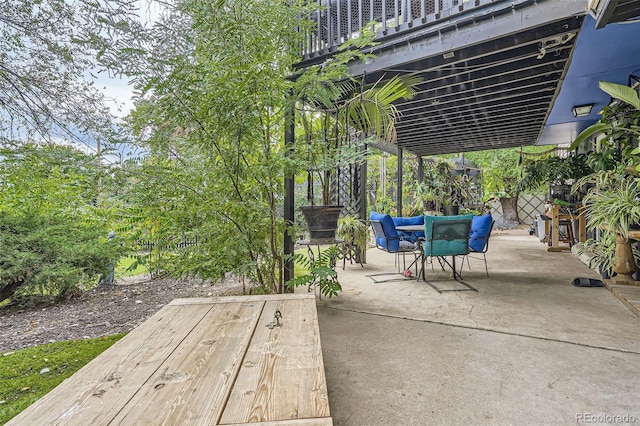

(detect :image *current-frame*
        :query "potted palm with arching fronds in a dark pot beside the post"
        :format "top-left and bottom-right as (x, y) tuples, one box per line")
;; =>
(295, 76), (419, 242)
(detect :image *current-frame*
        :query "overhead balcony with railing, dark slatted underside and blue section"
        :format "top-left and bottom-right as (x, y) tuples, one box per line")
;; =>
(299, 0), (640, 156)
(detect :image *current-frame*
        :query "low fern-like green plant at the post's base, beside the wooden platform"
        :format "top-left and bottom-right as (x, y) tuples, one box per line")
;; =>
(286, 245), (342, 297)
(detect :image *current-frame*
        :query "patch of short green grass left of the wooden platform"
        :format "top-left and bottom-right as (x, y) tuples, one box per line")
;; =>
(0, 334), (124, 424)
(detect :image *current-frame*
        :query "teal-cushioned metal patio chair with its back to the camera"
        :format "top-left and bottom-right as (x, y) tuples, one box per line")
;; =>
(419, 215), (476, 293)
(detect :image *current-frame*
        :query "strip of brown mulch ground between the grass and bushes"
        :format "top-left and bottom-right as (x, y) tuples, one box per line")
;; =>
(0, 277), (249, 354)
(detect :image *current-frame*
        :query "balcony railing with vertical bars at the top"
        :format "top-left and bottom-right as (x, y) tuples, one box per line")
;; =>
(302, 0), (500, 58)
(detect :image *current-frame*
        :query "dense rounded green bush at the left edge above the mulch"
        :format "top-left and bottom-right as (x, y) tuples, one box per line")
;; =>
(0, 144), (123, 300)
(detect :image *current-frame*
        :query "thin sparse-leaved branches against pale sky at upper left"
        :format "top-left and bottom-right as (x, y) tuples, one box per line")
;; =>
(0, 0), (141, 143)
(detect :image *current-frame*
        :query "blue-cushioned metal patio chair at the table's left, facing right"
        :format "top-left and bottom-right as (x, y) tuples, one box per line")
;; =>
(368, 212), (420, 282)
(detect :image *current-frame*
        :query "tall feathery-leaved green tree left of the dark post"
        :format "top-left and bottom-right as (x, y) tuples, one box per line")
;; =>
(121, 0), (400, 291)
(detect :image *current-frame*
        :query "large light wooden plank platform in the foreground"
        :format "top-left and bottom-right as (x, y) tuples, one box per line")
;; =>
(8, 294), (333, 426)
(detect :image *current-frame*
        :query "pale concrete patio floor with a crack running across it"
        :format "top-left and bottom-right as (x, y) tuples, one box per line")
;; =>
(318, 229), (640, 426)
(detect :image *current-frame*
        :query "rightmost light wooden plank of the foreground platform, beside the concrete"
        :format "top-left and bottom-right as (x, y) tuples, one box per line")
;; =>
(220, 300), (329, 424)
